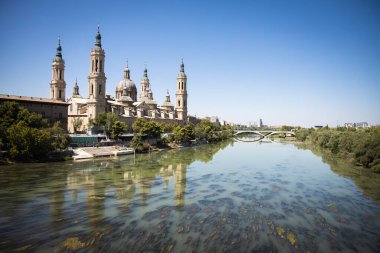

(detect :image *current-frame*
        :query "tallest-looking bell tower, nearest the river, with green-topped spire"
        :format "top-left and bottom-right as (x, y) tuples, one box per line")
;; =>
(88, 26), (107, 119)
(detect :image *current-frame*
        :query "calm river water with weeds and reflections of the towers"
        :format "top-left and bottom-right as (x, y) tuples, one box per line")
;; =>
(0, 141), (380, 252)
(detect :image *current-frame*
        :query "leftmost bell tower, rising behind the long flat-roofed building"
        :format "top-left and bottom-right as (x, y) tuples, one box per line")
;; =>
(50, 39), (66, 101)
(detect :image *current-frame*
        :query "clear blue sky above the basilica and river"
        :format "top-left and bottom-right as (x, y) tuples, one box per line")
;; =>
(0, 0), (380, 127)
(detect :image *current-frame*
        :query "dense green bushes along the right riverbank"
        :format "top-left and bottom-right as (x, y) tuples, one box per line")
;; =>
(296, 126), (380, 173)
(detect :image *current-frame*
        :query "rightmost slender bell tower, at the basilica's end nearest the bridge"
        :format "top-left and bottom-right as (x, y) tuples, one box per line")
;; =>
(176, 60), (187, 121)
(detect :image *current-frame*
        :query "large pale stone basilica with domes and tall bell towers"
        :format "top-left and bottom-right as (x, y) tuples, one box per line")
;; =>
(50, 27), (190, 133)
